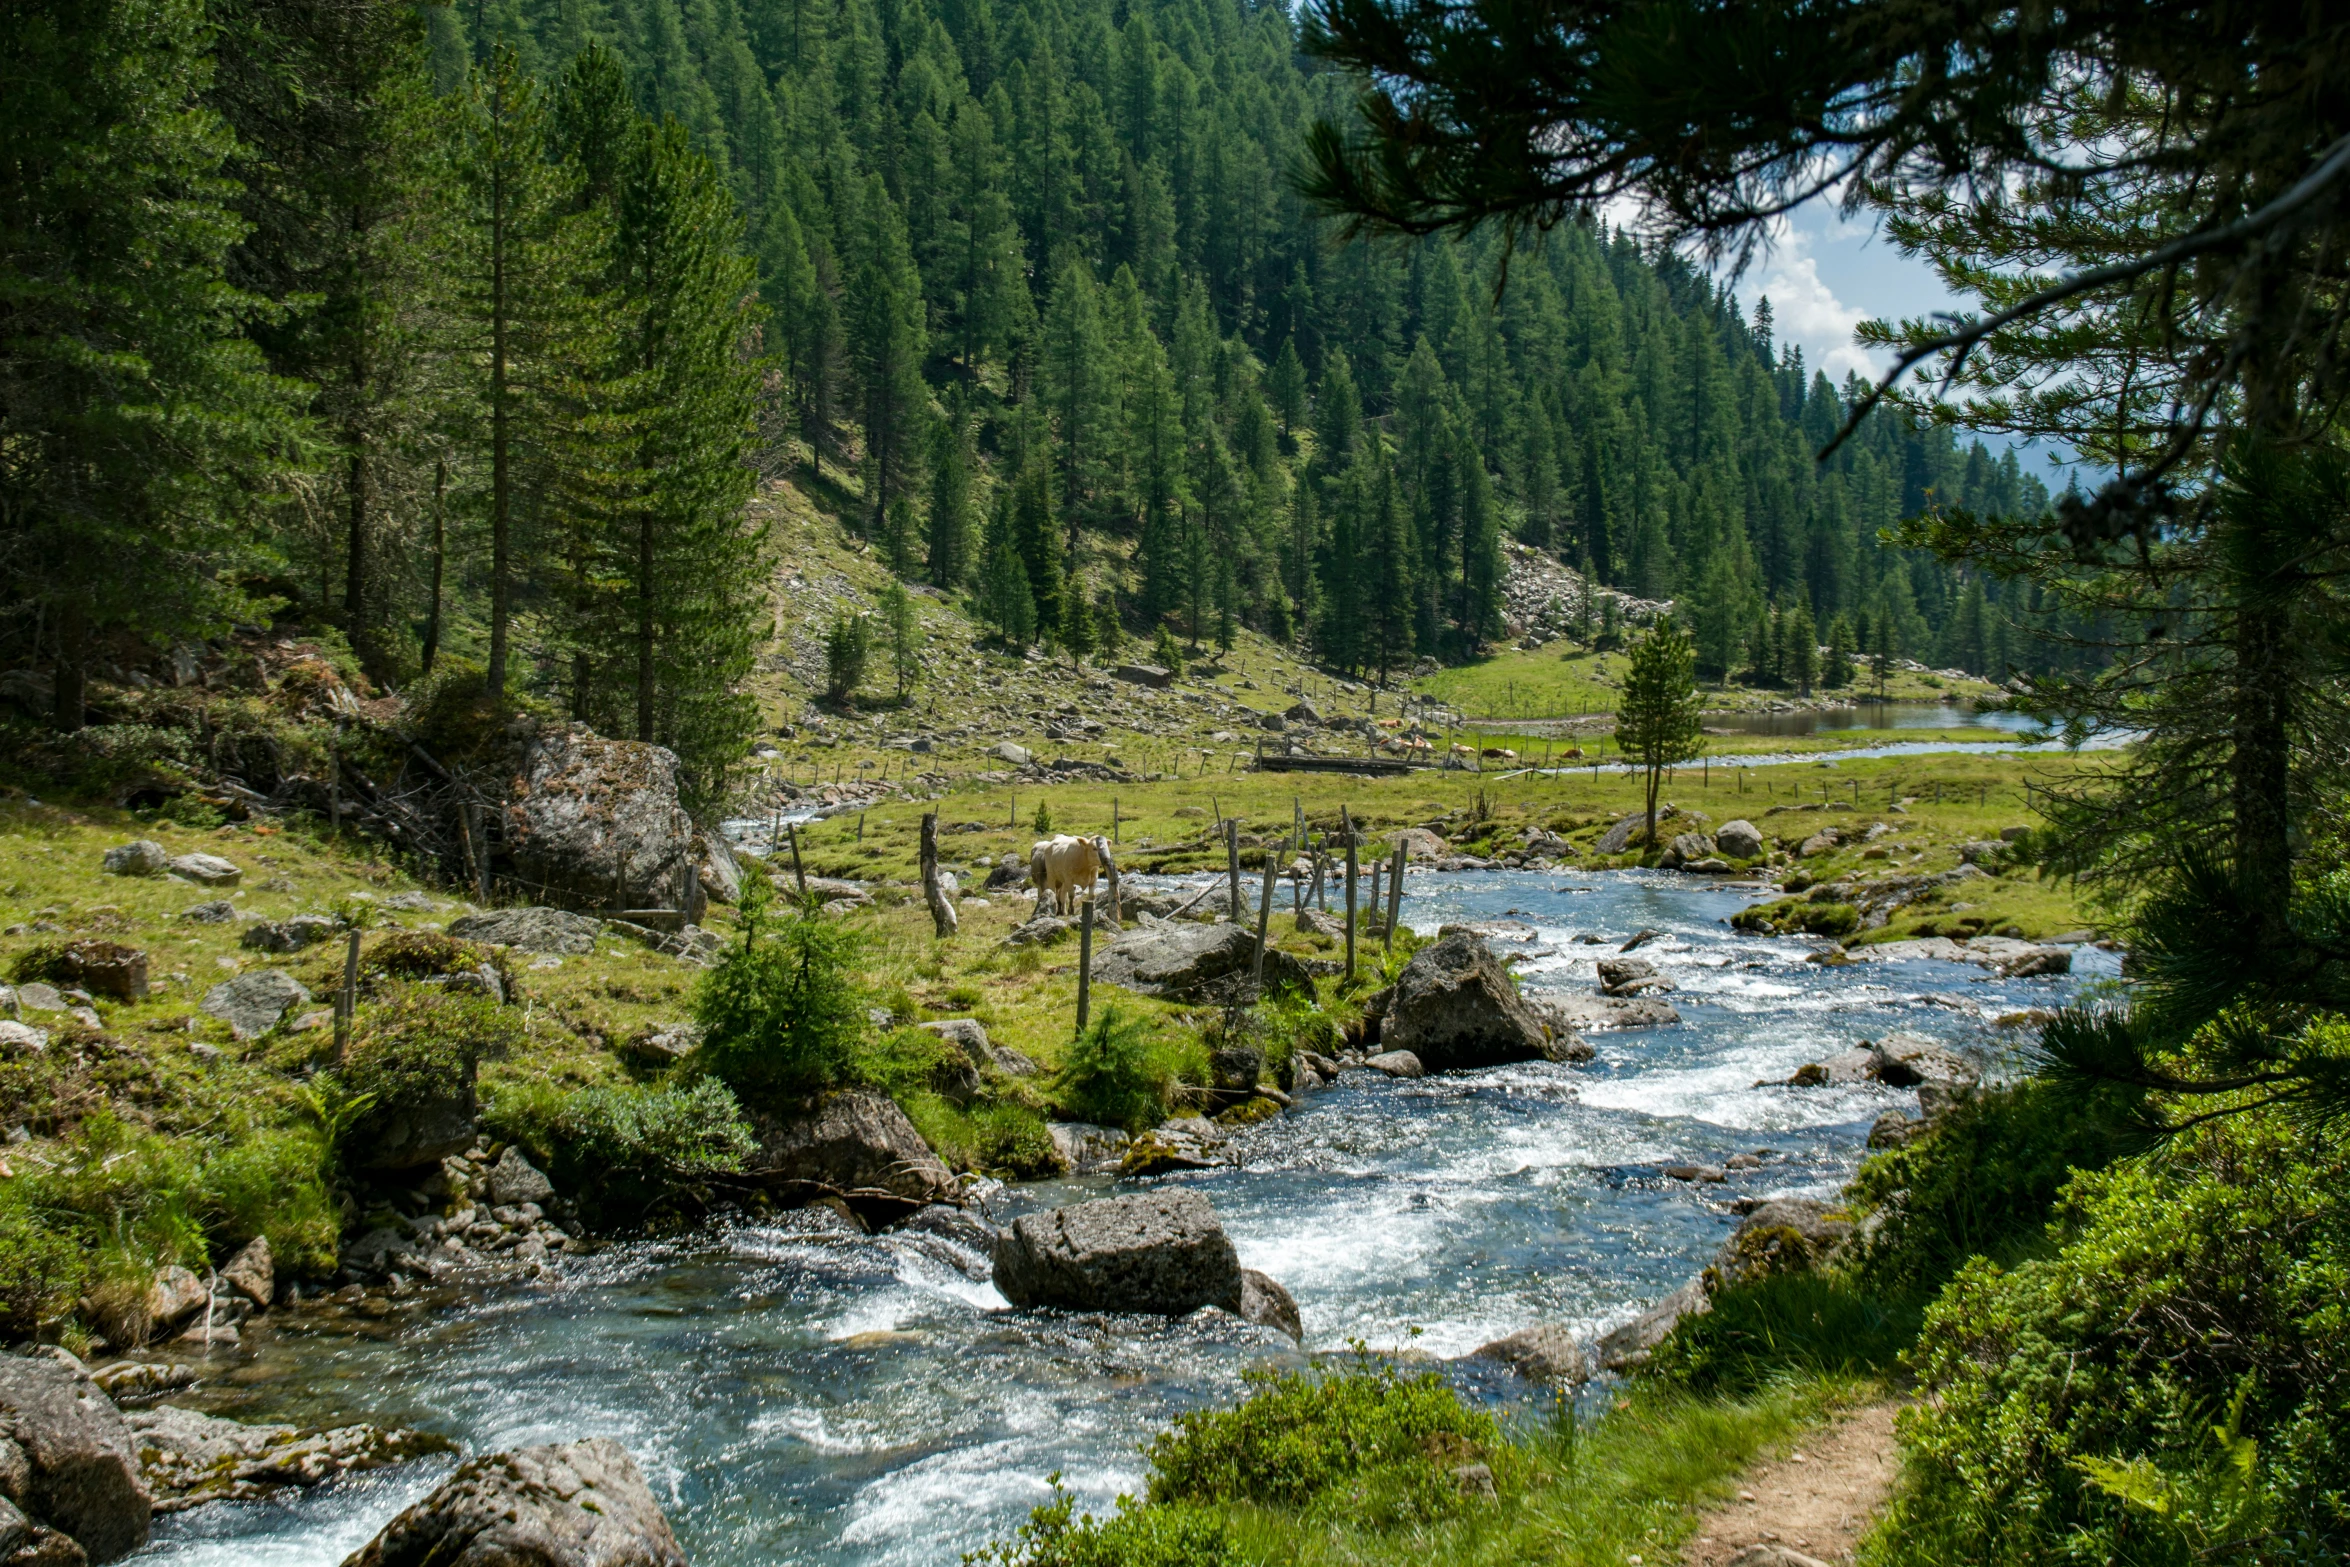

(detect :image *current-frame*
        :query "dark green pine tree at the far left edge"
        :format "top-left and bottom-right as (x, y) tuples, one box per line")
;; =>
(0, 0), (298, 728)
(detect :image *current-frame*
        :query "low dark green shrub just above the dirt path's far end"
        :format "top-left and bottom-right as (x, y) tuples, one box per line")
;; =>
(1647, 1273), (1925, 1395)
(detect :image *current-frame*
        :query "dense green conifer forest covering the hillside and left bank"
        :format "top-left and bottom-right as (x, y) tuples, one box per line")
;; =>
(0, 0), (2052, 803)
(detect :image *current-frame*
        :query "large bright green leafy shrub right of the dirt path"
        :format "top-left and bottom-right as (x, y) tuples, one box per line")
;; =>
(1866, 1114), (2350, 1567)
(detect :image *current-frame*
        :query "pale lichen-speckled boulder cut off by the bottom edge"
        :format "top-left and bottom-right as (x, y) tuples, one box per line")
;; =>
(343, 1438), (686, 1567)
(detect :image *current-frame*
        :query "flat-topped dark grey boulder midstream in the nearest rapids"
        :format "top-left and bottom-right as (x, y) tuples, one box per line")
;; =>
(994, 1191), (1241, 1316)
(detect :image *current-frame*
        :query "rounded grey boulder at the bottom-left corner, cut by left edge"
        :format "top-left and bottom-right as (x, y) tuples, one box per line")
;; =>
(0, 1356), (153, 1562)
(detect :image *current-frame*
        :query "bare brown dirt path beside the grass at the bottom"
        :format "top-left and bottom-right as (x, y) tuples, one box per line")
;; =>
(1683, 1403), (1901, 1567)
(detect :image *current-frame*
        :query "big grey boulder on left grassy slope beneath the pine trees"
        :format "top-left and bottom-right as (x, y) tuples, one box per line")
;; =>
(505, 724), (738, 921)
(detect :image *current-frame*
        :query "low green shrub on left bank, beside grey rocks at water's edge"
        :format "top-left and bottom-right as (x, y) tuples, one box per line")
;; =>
(482, 1076), (759, 1222)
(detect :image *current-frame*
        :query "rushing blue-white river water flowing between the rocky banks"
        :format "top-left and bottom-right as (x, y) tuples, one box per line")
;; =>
(141, 872), (2110, 1567)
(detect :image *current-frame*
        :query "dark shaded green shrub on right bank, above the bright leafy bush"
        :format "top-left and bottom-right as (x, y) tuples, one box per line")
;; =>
(1845, 1078), (2134, 1299)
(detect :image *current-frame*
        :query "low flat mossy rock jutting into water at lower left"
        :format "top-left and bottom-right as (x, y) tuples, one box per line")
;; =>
(125, 1405), (449, 1513)
